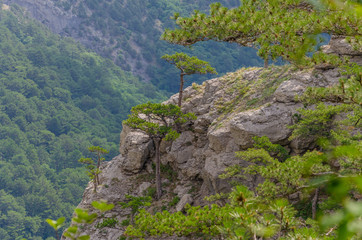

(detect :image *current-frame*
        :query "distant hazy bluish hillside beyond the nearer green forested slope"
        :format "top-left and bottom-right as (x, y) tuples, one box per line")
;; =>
(4, 0), (262, 93)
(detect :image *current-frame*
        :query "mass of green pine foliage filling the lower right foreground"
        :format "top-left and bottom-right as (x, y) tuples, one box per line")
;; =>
(126, 7), (362, 234)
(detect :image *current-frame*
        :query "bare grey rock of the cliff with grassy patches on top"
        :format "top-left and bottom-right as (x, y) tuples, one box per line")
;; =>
(64, 36), (362, 240)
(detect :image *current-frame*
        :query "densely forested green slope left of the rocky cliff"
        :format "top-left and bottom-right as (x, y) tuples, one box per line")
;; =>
(0, 7), (163, 240)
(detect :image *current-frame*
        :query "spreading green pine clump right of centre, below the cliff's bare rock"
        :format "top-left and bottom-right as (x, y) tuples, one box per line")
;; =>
(232, 142), (331, 199)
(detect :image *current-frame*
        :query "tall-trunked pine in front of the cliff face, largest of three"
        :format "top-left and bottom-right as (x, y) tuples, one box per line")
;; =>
(123, 103), (196, 199)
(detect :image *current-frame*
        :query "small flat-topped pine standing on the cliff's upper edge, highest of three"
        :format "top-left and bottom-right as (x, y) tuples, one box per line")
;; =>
(162, 53), (217, 107)
